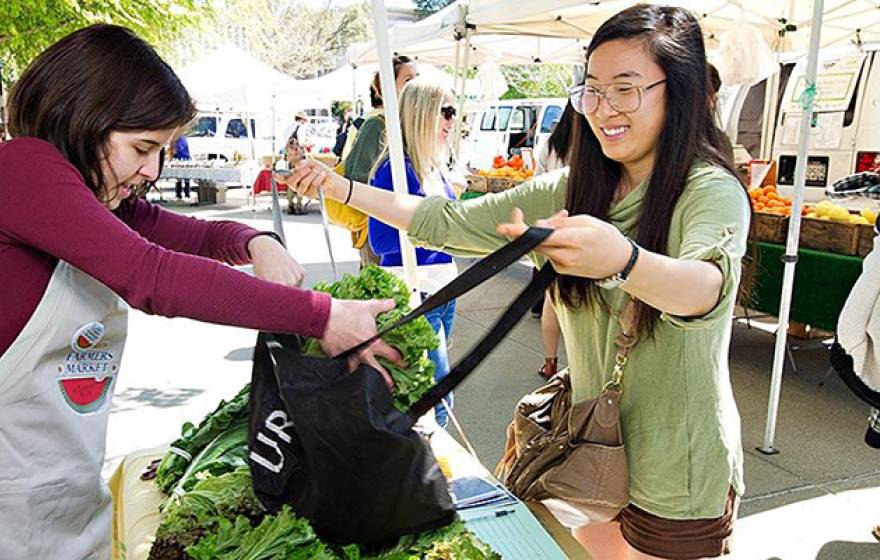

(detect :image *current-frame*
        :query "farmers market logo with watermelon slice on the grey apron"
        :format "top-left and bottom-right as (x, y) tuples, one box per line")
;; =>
(57, 321), (119, 414)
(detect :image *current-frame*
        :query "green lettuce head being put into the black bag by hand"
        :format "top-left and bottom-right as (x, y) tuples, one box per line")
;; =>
(303, 266), (439, 411)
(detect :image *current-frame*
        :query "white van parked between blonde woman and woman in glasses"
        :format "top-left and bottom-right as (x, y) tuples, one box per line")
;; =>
(466, 98), (568, 169)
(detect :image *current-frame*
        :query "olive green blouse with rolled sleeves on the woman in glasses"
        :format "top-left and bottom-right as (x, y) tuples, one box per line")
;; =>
(409, 164), (750, 519)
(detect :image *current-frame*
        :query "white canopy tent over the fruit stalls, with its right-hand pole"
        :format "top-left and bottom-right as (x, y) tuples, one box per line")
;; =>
(361, 0), (868, 453)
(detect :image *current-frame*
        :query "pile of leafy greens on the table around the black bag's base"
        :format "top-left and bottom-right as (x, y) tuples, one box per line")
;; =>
(149, 394), (500, 560)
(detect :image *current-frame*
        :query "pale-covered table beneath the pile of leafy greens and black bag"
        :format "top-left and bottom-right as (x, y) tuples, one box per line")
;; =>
(110, 430), (590, 560)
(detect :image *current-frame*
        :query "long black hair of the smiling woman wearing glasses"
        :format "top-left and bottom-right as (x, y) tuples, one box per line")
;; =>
(556, 4), (744, 334)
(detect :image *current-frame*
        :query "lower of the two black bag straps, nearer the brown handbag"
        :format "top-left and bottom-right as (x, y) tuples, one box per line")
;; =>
(406, 262), (556, 427)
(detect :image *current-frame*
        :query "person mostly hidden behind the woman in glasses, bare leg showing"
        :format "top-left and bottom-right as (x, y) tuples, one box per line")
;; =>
(532, 103), (577, 379)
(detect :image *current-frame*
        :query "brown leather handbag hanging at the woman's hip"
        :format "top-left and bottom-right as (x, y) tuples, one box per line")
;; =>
(495, 300), (637, 522)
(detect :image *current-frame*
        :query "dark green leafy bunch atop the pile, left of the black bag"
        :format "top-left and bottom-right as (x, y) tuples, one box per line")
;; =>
(156, 384), (250, 494)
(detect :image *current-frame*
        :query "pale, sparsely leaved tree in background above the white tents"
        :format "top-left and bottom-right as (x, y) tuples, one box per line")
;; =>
(218, 0), (371, 78)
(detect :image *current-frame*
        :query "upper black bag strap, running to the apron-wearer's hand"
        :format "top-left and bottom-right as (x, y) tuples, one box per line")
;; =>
(334, 227), (553, 359)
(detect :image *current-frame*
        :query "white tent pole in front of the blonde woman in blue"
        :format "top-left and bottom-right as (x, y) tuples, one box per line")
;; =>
(372, 0), (421, 308)
